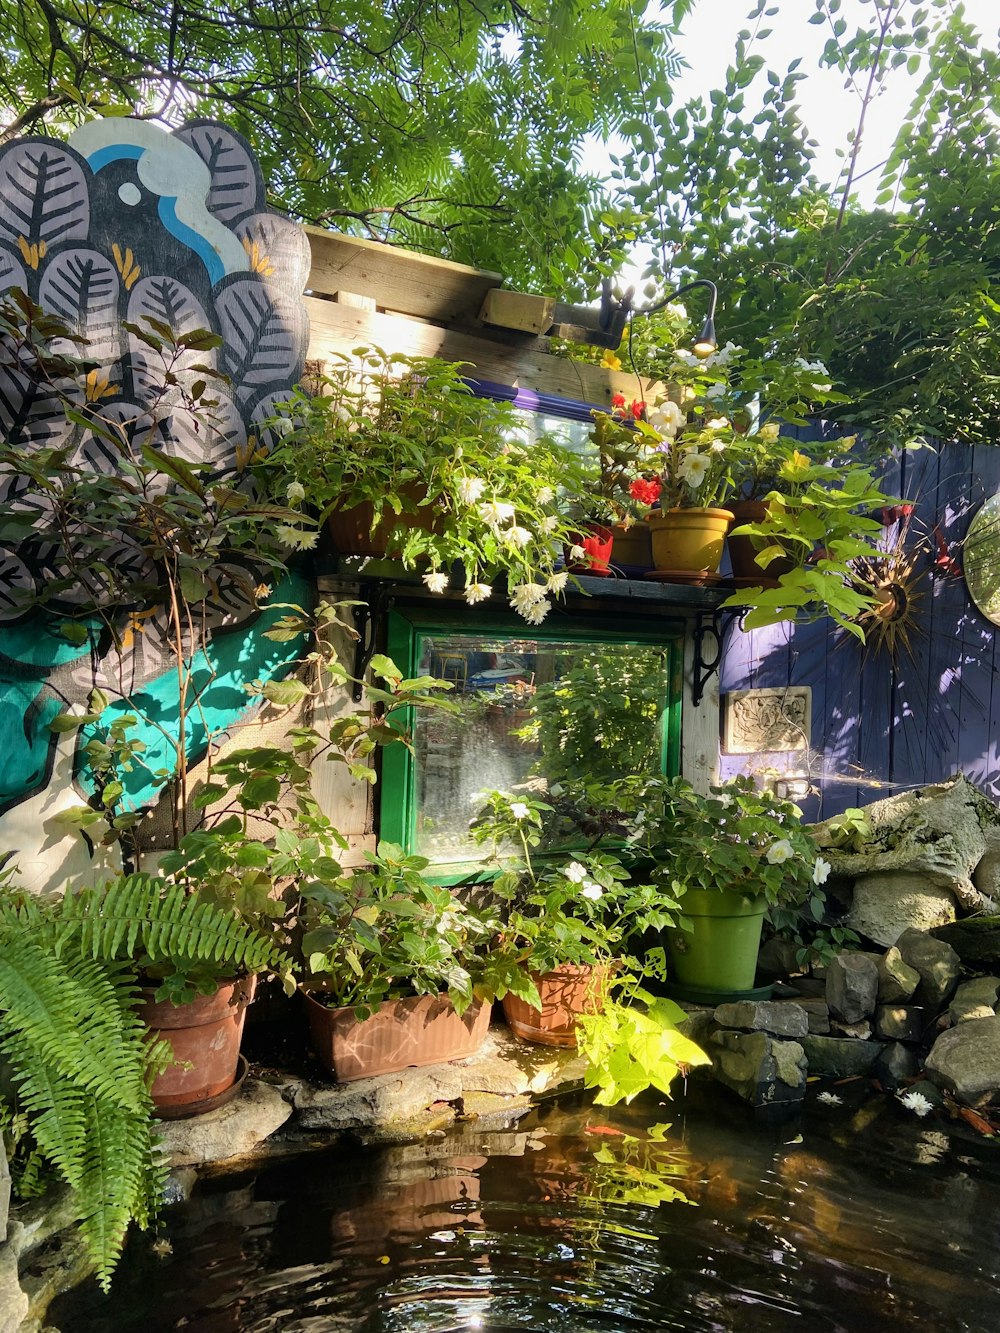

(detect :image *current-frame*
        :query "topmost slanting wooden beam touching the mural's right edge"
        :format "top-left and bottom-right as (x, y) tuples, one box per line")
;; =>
(305, 227), (503, 324)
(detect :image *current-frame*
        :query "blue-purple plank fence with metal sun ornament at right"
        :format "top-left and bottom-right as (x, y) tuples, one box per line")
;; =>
(721, 432), (1000, 818)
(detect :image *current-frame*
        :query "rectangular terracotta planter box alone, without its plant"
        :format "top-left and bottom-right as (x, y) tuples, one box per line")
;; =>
(303, 990), (491, 1082)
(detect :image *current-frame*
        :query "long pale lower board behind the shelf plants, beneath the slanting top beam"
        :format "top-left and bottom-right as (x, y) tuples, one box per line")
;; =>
(305, 297), (665, 407)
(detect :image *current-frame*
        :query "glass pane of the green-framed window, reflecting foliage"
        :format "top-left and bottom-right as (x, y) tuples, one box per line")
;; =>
(413, 633), (669, 862)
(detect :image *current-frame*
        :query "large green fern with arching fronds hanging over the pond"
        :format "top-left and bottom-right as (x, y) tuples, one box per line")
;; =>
(0, 874), (288, 1289)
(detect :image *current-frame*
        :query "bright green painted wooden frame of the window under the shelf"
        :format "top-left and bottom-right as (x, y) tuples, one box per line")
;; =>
(377, 604), (684, 882)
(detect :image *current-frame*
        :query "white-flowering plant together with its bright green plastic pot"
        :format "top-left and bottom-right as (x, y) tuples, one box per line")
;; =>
(629, 777), (829, 998)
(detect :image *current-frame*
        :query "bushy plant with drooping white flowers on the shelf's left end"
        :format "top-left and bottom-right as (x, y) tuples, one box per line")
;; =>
(256, 348), (575, 624)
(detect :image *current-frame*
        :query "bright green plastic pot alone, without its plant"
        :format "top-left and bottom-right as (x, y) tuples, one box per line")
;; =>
(667, 889), (767, 990)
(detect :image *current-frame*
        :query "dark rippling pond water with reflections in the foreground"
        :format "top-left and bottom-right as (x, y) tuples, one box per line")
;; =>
(49, 1088), (1000, 1333)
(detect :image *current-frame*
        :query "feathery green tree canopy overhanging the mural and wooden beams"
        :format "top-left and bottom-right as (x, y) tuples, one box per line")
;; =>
(0, 0), (691, 288)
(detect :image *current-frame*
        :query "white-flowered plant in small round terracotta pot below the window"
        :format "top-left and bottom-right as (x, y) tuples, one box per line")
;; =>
(472, 788), (676, 1046)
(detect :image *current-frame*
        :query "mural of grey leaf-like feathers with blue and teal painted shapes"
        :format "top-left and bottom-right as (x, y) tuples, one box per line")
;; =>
(0, 119), (309, 889)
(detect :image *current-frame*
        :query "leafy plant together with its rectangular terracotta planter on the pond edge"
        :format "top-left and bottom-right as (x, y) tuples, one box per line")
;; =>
(301, 842), (496, 1082)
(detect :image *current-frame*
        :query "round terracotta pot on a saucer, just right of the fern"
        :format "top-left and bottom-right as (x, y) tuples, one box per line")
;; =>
(139, 977), (257, 1116)
